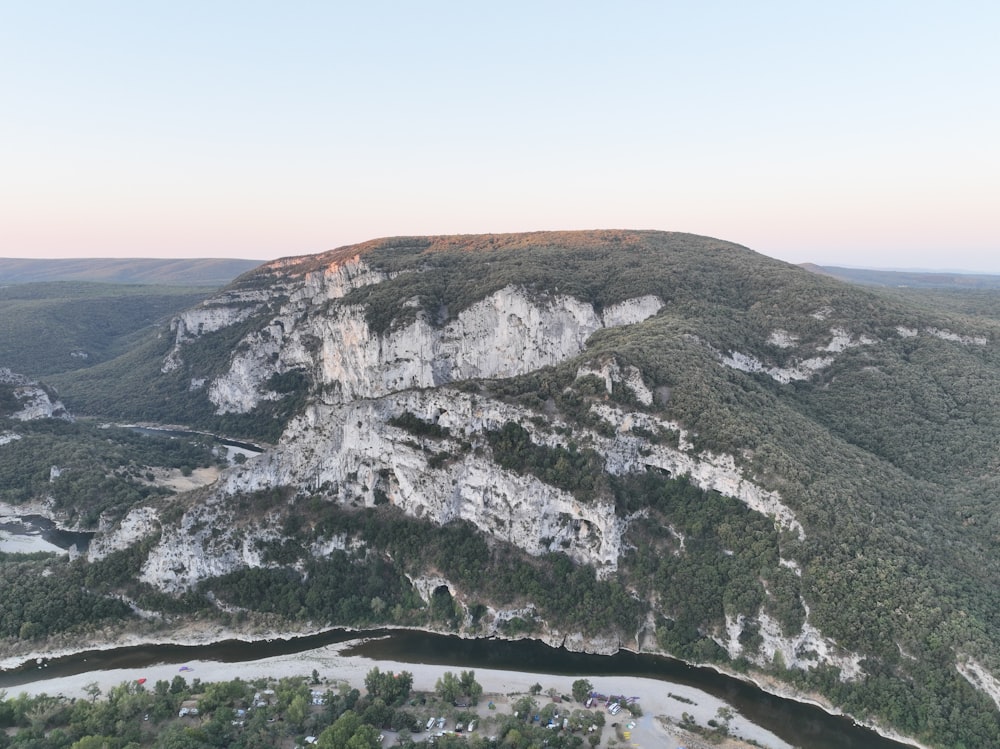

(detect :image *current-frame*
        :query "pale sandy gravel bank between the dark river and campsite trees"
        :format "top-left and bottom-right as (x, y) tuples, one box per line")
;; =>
(10, 643), (792, 749)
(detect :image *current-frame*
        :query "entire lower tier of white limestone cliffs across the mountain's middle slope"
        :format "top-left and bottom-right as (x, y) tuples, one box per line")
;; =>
(109, 376), (804, 589)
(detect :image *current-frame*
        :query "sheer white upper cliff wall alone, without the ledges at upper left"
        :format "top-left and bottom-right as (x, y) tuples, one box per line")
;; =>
(209, 286), (662, 413)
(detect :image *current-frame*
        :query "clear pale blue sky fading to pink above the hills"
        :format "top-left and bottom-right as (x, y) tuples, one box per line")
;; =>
(0, 0), (1000, 272)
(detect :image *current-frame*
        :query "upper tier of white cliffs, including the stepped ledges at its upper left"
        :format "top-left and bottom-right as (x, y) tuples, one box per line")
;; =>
(162, 248), (663, 414)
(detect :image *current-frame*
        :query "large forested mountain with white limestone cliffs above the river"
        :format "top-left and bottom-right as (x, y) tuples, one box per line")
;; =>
(0, 231), (1000, 749)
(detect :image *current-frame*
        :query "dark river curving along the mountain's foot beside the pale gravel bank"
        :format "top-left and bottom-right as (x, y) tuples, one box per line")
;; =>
(0, 629), (912, 749)
